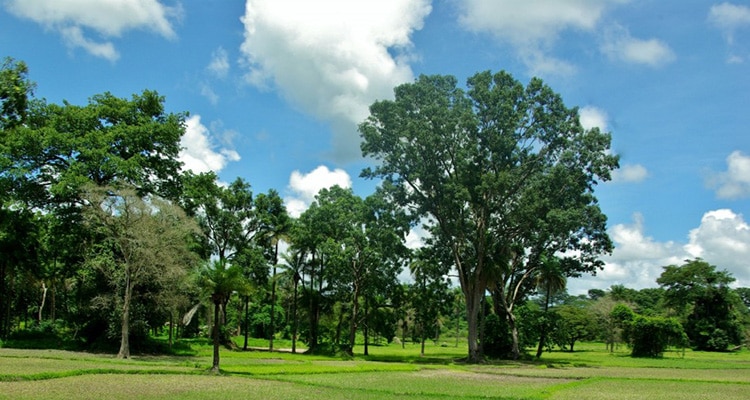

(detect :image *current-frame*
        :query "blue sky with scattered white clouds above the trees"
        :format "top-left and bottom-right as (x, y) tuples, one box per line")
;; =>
(0, 0), (750, 294)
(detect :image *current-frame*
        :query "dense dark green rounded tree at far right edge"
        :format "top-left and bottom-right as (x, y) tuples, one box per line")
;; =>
(657, 258), (743, 351)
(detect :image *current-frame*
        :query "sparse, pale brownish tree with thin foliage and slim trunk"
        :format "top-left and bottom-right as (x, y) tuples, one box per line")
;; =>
(84, 186), (197, 358)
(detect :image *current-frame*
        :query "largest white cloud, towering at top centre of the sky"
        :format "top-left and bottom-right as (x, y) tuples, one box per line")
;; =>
(241, 0), (431, 161)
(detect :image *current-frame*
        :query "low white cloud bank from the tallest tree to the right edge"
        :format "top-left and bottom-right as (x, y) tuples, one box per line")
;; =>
(568, 209), (750, 294)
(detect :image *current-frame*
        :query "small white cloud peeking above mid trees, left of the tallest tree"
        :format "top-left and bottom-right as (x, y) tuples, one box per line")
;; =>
(284, 165), (352, 217)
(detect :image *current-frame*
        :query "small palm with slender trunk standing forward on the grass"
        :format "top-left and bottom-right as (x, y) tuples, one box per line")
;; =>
(198, 260), (247, 373)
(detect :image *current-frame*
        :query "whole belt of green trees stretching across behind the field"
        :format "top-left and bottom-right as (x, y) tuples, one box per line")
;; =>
(0, 58), (750, 371)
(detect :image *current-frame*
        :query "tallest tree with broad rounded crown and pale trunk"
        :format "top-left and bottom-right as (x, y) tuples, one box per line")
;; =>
(360, 72), (617, 362)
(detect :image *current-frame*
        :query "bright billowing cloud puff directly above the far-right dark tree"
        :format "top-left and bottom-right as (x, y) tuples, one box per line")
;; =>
(685, 209), (750, 287)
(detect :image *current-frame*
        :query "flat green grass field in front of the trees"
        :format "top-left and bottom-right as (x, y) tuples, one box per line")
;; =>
(0, 341), (750, 400)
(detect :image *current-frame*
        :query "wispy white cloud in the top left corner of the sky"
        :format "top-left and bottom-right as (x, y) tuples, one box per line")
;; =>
(5, 0), (182, 61)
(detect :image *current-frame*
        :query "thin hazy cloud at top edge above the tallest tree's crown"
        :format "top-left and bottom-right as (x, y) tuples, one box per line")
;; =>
(459, 0), (627, 75)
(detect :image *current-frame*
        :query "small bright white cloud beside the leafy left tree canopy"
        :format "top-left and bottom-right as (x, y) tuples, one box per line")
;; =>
(179, 115), (240, 173)
